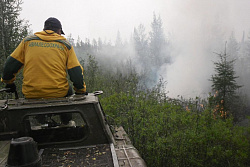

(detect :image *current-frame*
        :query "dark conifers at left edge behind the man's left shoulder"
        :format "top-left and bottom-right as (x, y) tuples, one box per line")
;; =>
(0, 0), (29, 98)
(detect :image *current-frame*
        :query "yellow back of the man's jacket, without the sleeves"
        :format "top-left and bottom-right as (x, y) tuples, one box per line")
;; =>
(21, 31), (71, 98)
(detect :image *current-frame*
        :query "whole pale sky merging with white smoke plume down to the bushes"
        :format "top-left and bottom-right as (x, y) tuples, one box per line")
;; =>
(21, 0), (250, 96)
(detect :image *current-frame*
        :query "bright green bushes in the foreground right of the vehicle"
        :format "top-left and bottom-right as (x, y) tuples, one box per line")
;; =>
(102, 92), (250, 167)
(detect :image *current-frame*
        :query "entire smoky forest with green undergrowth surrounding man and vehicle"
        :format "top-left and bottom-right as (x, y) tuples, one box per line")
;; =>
(0, 0), (250, 167)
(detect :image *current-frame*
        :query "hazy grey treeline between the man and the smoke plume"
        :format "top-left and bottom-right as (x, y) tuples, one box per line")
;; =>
(67, 14), (171, 87)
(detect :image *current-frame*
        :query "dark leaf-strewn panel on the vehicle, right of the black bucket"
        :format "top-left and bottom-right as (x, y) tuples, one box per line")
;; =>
(42, 144), (113, 167)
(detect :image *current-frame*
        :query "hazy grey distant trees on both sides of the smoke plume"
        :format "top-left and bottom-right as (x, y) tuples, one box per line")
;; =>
(68, 14), (250, 107)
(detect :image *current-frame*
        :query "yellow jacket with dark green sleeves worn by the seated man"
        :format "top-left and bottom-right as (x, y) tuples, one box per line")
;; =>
(1, 30), (86, 98)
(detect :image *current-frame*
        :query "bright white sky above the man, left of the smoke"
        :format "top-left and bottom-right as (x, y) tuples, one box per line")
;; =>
(21, 0), (161, 41)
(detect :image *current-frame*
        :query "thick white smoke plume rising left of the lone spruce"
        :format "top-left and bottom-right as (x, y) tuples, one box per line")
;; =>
(158, 0), (250, 98)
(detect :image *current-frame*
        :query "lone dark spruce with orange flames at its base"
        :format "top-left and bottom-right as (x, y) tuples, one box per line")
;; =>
(211, 44), (241, 118)
